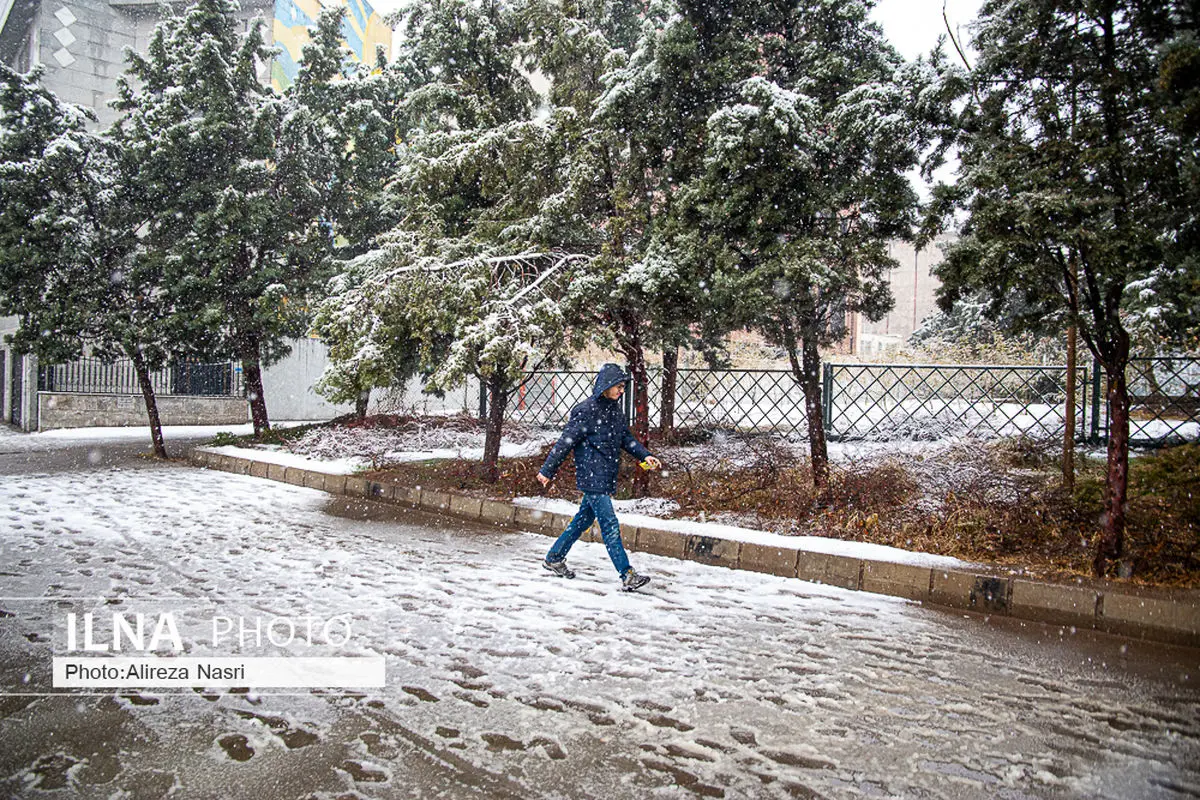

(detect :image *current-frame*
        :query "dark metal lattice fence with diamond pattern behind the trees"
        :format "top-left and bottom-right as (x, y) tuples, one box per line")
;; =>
(492, 357), (1200, 446)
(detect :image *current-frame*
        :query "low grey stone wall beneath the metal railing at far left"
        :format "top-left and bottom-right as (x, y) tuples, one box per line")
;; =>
(37, 392), (250, 431)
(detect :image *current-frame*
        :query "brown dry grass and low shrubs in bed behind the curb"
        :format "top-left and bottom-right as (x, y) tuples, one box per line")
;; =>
(304, 421), (1200, 587)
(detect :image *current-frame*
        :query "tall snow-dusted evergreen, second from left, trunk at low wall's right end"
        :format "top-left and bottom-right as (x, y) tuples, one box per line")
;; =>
(113, 0), (330, 433)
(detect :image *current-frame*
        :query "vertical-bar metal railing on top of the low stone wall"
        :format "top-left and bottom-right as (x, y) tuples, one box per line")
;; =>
(37, 359), (246, 397)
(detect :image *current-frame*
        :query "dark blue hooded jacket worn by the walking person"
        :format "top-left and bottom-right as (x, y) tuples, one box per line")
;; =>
(541, 363), (650, 494)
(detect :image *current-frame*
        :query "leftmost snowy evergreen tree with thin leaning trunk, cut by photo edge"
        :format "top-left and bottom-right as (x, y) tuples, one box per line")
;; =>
(0, 65), (180, 458)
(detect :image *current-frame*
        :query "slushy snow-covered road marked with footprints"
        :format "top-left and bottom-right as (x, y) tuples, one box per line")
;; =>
(0, 455), (1200, 800)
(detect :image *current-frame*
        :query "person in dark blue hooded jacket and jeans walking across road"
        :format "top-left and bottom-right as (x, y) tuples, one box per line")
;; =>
(538, 363), (662, 590)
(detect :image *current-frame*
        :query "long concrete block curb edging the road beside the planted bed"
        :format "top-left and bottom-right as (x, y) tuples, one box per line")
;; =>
(188, 447), (1200, 648)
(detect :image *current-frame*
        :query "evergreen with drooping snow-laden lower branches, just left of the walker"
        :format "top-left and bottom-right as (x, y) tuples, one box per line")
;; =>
(330, 0), (563, 480)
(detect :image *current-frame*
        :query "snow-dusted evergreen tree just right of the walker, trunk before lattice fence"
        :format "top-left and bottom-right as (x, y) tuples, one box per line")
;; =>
(684, 0), (941, 488)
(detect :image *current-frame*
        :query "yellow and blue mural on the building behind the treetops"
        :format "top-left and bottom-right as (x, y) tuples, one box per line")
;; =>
(271, 0), (391, 91)
